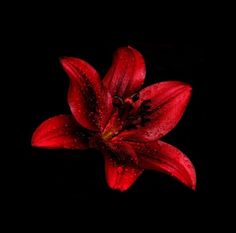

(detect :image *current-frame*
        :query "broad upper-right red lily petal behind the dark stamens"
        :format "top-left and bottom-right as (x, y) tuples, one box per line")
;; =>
(116, 81), (192, 141)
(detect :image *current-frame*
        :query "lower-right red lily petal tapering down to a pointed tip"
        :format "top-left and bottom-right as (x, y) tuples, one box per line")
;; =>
(130, 141), (196, 190)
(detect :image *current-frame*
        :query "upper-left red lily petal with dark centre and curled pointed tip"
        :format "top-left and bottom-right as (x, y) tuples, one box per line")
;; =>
(61, 58), (112, 130)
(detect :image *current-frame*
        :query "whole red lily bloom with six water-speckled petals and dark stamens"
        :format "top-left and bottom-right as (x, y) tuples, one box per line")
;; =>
(32, 47), (196, 191)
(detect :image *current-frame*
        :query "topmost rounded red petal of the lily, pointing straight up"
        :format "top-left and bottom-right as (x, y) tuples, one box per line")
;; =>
(103, 47), (146, 97)
